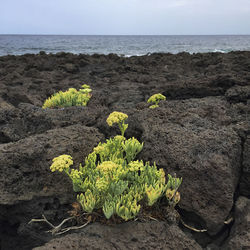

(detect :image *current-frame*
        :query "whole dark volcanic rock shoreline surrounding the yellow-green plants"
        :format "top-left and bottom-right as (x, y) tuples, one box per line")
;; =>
(0, 52), (250, 249)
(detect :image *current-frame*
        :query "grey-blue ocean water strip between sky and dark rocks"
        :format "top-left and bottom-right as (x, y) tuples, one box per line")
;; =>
(0, 35), (250, 56)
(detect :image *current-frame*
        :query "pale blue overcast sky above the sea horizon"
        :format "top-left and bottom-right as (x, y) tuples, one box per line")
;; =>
(0, 0), (250, 35)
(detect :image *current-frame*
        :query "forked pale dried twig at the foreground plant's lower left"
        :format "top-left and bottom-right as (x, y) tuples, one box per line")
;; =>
(28, 215), (90, 235)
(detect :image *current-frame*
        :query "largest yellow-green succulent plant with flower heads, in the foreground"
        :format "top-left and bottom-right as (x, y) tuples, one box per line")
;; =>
(50, 112), (182, 221)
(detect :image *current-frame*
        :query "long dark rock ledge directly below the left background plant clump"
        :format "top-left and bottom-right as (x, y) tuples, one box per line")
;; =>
(0, 103), (107, 143)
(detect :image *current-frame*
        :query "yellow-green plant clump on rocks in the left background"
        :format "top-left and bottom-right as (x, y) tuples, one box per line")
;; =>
(43, 84), (92, 108)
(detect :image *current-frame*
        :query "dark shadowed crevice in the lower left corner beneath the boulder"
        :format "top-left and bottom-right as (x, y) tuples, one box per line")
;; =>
(0, 197), (73, 250)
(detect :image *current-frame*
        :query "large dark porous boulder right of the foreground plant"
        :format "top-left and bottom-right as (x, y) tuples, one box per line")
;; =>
(135, 97), (241, 234)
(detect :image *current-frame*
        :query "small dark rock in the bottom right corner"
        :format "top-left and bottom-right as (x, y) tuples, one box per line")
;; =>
(222, 196), (250, 250)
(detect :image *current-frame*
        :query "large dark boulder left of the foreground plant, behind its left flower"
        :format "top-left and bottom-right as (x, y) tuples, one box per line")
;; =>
(0, 125), (103, 205)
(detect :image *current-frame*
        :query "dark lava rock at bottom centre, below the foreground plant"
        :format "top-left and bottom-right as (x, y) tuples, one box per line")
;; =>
(34, 222), (202, 250)
